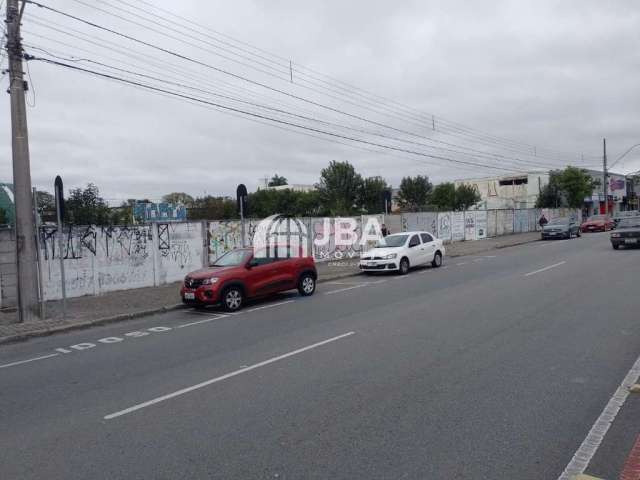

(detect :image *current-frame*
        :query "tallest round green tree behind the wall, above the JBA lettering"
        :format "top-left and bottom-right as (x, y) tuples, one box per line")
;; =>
(316, 160), (362, 215)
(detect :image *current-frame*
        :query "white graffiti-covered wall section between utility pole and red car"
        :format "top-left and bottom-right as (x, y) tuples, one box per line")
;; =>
(39, 223), (203, 300)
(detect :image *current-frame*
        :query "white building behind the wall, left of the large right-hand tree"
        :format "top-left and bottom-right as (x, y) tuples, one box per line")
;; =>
(454, 171), (549, 210)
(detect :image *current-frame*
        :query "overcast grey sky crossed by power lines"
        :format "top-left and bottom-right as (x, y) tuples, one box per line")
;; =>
(0, 0), (640, 202)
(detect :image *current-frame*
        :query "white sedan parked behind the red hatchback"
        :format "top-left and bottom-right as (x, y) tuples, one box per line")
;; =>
(360, 232), (445, 275)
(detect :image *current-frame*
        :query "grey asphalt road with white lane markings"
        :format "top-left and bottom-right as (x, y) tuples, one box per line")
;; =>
(0, 234), (640, 480)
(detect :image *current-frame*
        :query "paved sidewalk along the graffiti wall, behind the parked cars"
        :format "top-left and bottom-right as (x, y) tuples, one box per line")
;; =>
(0, 232), (540, 344)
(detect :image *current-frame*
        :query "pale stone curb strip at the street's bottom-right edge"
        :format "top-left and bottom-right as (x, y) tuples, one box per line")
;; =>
(558, 350), (640, 480)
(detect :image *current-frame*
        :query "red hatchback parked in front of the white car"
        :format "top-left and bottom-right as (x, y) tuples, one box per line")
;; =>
(180, 248), (318, 311)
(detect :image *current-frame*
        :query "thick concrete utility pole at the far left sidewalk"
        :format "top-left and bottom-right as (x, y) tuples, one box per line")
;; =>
(6, 0), (38, 322)
